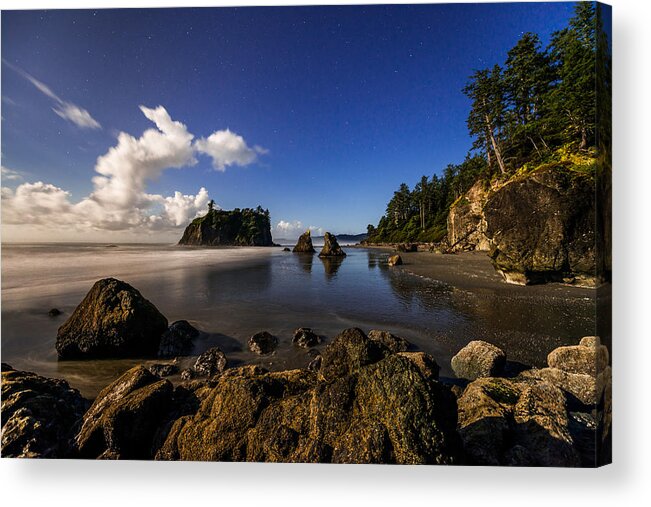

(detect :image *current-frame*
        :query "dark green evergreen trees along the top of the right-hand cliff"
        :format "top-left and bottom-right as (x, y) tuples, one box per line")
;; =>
(367, 2), (611, 242)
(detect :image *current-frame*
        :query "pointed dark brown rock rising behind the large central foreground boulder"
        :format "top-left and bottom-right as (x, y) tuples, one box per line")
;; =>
(319, 328), (391, 381)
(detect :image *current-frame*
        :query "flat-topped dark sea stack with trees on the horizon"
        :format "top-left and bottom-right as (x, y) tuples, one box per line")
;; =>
(179, 208), (273, 246)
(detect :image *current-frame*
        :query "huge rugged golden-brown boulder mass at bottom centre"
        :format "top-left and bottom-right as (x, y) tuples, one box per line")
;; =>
(157, 329), (460, 464)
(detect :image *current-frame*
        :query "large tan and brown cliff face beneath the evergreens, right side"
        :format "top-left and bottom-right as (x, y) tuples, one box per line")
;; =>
(448, 166), (610, 285)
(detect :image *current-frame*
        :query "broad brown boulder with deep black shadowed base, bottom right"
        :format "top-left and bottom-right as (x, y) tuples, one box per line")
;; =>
(458, 378), (581, 467)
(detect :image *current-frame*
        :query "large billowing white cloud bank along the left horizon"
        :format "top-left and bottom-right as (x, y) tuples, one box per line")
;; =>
(2, 106), (260, 239)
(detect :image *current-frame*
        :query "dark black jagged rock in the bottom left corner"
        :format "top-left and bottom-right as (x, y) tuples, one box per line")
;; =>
(0, 363), (88, 458)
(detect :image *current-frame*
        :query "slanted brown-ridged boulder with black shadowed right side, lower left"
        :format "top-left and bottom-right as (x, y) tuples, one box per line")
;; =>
(75, 366), (173, 459)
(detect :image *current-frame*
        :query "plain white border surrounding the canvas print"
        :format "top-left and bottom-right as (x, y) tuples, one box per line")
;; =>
(0, 0), (651, 507)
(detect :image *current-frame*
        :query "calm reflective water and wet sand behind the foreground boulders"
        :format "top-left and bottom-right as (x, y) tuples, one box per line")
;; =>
(2, 245), (594, 397)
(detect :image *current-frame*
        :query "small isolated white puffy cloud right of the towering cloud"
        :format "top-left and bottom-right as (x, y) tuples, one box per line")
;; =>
(194, 129), (269, 171)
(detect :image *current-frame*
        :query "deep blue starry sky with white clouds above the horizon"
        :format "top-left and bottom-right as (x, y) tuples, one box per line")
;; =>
(1, 2), (574, 242)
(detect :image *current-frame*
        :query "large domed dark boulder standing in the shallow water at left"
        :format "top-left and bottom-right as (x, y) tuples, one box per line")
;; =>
(56, 278), (167, 359)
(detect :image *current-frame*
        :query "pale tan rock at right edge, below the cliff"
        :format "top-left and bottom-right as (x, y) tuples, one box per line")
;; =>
(547, 336), (610, 377)
